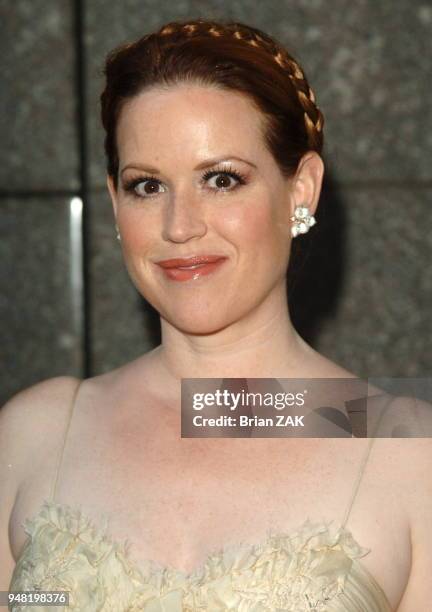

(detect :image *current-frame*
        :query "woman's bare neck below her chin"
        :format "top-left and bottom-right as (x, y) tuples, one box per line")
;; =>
(148, 288), (316, 397)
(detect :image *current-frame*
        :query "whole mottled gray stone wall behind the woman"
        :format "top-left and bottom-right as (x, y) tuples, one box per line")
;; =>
(0, 0), (432, 401)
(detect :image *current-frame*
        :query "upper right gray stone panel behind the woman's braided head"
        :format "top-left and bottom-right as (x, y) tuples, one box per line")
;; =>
(86, 0), (432, 186)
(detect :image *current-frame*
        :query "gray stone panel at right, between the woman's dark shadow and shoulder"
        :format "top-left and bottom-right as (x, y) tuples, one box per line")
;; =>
(316, 187), (432, 377)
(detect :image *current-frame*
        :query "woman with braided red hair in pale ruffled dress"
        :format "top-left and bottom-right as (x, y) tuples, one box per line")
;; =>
(0, 20), (432, 612)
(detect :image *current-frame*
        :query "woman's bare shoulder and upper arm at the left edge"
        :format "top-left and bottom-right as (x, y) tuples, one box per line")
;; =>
(0, 376), (80, 590)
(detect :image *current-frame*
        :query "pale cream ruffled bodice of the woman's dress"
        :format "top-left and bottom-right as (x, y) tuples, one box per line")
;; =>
(11, 500), (390, 612)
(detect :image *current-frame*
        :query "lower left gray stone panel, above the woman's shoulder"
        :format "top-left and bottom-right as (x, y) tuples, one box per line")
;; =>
(0, 197), (81, 400)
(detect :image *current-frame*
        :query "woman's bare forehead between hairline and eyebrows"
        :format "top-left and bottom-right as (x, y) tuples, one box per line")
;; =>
(117, 84), (266, 161)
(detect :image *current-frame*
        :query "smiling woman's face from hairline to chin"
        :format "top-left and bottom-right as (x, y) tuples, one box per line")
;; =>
(108, 85), (301, 334)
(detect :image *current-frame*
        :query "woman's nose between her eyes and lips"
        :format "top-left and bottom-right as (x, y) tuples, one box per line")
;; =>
(162, 192), (207, 242)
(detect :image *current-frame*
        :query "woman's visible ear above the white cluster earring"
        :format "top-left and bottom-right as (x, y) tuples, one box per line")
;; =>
(292, 151), (324, 215)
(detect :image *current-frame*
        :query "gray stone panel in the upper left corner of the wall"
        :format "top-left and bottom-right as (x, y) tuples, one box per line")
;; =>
(0, 0), (79, 192)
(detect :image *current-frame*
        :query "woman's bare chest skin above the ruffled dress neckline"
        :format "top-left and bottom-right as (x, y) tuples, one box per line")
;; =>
(12, 402), (410, 601)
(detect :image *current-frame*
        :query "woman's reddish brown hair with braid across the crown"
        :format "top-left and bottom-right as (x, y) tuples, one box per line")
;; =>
(100, 19), (324, 188)
